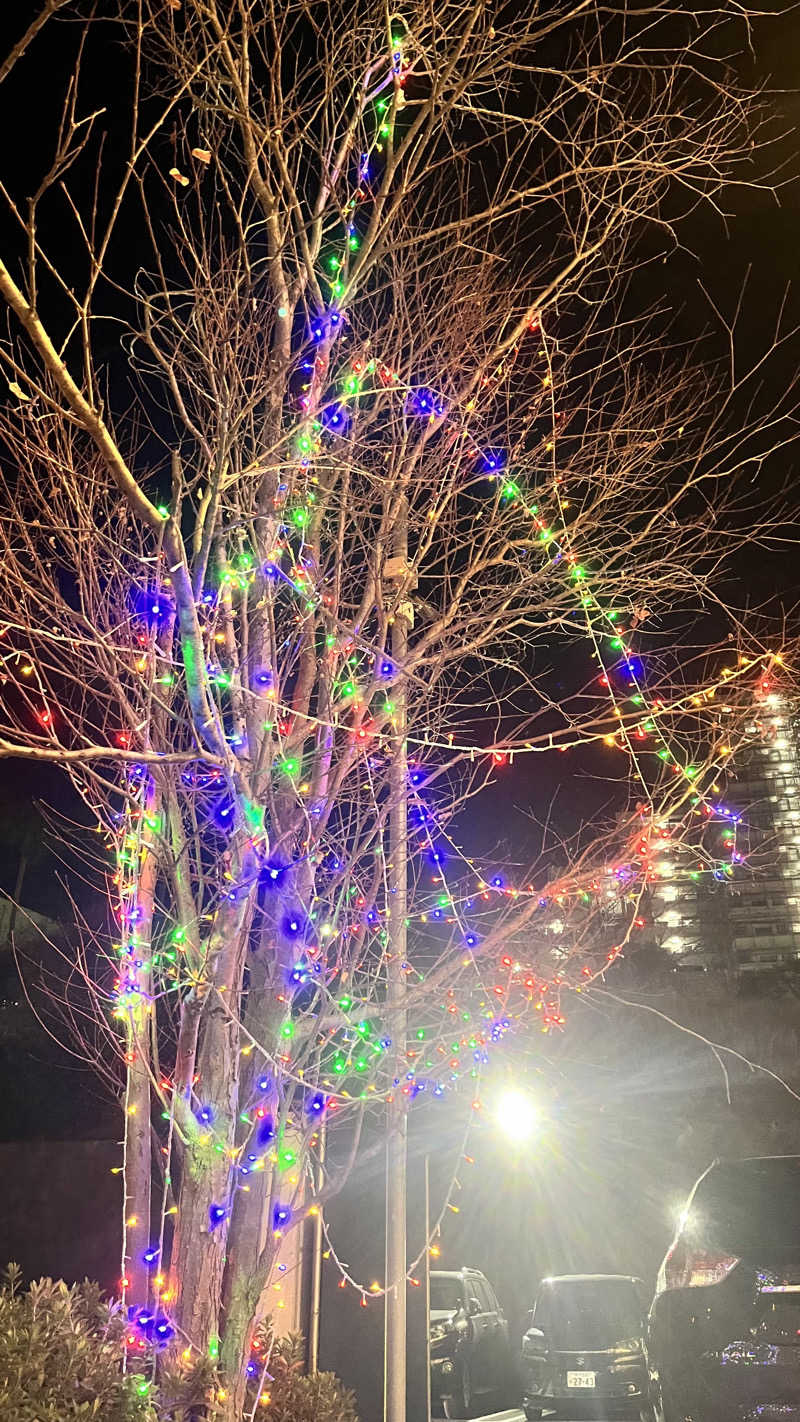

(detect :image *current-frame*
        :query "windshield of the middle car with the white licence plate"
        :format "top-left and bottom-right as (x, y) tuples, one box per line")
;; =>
(533, 1280), (642, 1351)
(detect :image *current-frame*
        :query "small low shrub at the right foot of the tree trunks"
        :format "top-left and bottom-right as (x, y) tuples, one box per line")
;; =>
(247, 1325), (358, 1422)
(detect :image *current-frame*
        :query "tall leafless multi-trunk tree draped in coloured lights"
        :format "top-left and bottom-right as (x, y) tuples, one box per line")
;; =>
(0, 0), (793, 1418)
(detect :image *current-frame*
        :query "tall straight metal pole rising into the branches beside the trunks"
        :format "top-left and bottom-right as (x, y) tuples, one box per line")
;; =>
(384, 495), (413, 1422)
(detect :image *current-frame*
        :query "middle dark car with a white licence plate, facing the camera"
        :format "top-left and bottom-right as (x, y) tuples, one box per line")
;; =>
(521, 1274), (659, 1422)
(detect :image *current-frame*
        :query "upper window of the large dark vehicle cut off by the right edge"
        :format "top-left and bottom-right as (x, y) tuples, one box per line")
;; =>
(686, 1156), (800, 1251)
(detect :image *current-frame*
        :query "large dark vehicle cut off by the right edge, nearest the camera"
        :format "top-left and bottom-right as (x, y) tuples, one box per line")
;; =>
(649, 1156), (800, 1422)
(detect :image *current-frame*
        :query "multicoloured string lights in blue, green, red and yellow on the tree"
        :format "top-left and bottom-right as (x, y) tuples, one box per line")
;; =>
(1, 19), (780, 1387)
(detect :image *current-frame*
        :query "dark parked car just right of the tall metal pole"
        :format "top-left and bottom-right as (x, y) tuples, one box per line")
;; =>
(431, 1268), (513, 1418)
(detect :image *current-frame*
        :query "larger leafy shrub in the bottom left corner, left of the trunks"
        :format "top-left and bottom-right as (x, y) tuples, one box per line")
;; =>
(0, 1264), (156, 1422)
